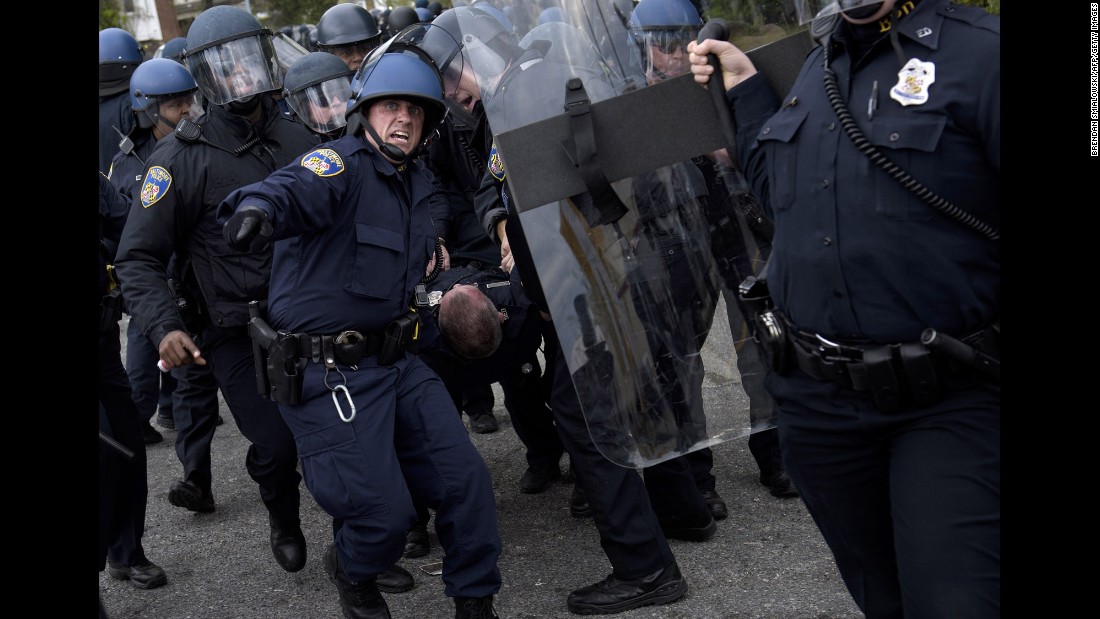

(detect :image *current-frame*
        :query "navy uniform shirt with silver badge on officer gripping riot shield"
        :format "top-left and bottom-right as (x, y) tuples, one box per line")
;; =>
(727, 0), (1001, 343)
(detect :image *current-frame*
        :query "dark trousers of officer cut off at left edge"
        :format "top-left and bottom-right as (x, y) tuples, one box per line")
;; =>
(99, 324), (149, 571)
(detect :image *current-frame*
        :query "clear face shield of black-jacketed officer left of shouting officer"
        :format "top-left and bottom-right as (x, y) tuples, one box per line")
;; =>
(187, 33), (283, 106)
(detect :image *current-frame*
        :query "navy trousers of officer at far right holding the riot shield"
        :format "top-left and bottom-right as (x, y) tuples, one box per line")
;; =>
(767, 371), (1001, 619)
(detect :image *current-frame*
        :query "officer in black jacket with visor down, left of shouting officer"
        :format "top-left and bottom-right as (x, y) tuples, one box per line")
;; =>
(117, 5), (317, 572)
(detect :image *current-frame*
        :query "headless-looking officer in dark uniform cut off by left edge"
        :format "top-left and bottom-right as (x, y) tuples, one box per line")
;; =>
(98, 173), (168, 589)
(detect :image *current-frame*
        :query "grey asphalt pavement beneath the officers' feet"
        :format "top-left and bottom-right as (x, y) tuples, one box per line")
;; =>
(99, 318), (864, 619)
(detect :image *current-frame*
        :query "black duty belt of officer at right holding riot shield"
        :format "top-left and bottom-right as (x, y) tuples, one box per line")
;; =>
(783, 317), (1000, 412)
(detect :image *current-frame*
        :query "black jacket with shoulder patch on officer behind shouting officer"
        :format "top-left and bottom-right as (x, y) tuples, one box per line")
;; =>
(116, 96), (318, 342)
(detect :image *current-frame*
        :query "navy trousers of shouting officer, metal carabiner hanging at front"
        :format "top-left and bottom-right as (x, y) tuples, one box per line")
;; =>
(279, 355), (501, 597)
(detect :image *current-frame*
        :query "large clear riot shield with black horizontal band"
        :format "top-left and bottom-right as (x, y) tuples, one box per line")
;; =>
(459, 0), (809, 467)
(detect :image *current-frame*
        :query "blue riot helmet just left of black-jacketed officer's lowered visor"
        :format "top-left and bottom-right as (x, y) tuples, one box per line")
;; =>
(130, 58), (202, 134)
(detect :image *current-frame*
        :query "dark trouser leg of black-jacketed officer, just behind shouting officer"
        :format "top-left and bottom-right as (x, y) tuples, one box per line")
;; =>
(201, 325), (301, 524)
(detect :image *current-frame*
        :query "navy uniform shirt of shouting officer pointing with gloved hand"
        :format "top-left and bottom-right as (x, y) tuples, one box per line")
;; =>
(218, 135), (436, 334)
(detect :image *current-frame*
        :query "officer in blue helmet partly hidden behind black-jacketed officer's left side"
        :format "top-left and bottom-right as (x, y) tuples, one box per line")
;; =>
(107, 58), (209, 444)
